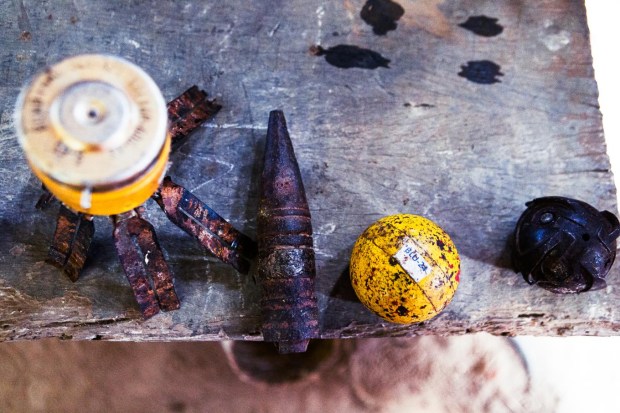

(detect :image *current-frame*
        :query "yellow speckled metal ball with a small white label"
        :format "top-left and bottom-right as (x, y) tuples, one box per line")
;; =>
(350, 214), (460, 324)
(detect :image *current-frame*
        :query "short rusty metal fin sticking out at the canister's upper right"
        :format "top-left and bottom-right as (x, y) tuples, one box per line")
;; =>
(168, 86), (222, 147)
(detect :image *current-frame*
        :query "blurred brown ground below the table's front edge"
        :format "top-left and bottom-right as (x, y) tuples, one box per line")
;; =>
(0, 334), (557, 413)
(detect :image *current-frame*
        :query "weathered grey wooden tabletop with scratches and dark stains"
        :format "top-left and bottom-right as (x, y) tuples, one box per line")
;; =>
(0, 0), (620, 341)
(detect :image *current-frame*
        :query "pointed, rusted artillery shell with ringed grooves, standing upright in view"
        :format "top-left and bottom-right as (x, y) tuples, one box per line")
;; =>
(258, 111), (319, 353)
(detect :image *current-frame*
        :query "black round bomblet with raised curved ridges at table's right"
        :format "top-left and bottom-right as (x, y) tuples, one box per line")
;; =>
(513, 196), (620, 294)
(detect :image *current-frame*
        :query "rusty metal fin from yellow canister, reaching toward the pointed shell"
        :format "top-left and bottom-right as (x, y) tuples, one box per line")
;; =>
(154, 177), (256, 274)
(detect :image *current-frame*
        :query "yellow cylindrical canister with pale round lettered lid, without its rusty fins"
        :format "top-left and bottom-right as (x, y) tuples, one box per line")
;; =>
(15, 55), (170, 215)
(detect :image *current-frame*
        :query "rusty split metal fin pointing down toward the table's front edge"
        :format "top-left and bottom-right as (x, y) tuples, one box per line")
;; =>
(113, 208), (180, 319)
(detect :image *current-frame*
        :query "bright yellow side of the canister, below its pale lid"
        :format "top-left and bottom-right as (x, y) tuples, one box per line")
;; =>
(30, 136), (170, 215)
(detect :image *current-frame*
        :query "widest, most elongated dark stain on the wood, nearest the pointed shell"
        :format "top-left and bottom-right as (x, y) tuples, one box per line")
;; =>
(310, 44), (390, 69)
